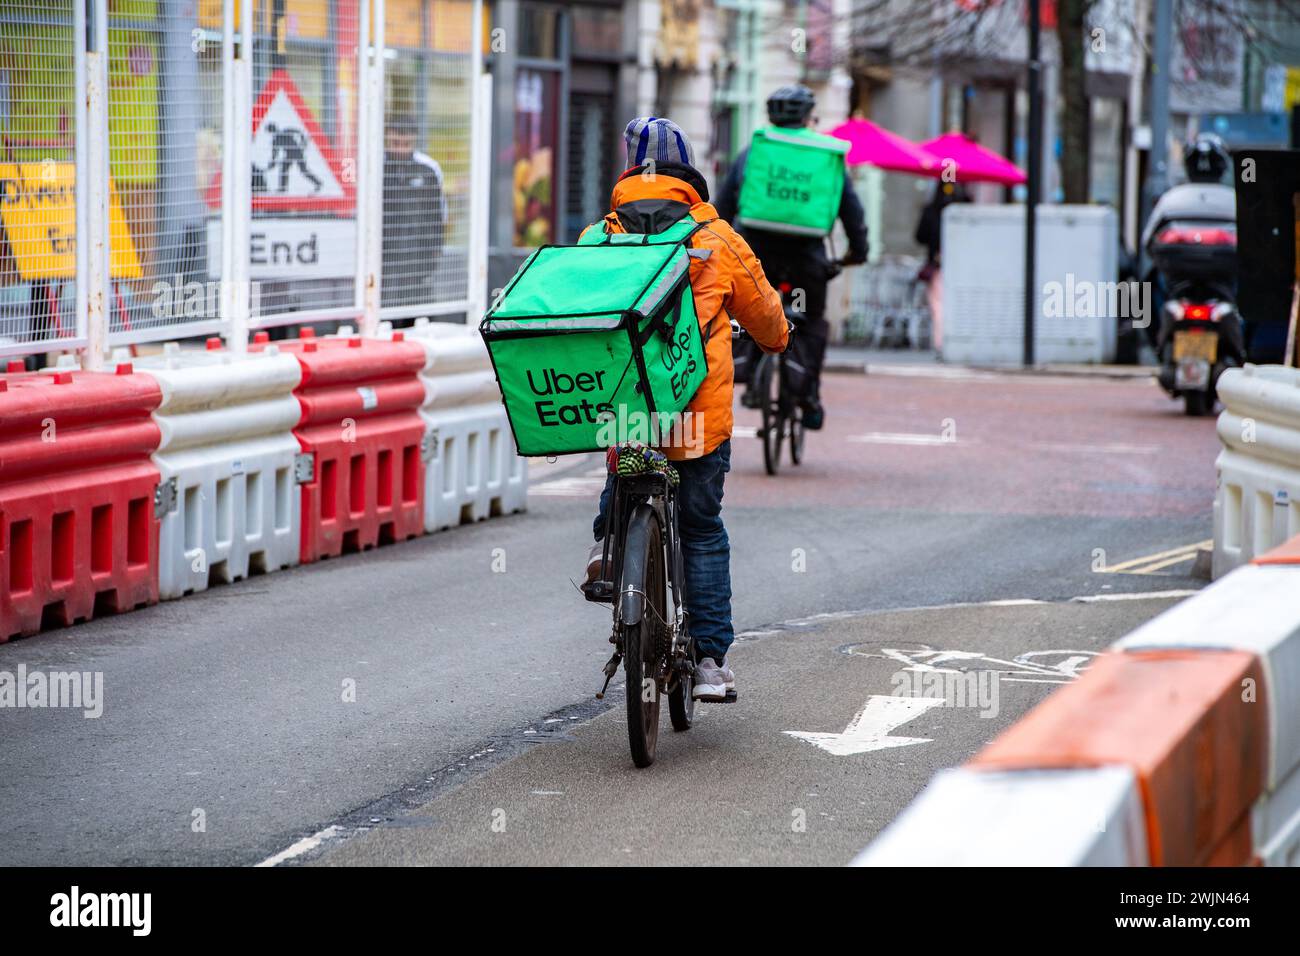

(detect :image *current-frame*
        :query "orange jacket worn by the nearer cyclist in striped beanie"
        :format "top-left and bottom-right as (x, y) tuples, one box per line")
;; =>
(588, 170), (789, 460)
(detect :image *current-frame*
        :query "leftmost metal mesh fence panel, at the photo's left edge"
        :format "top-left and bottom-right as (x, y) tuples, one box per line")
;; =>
(0, 0), (78, 349)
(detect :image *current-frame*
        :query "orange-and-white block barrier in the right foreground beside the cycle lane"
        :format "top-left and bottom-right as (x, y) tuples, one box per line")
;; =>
(854, 538), (1300, 866)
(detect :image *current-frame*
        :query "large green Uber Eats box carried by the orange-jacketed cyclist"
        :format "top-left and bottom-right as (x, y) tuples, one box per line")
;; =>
(478, 216), (709, 455)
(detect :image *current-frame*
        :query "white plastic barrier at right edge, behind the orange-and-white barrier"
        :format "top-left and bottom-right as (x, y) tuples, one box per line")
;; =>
(1213, 365), (1300, 578)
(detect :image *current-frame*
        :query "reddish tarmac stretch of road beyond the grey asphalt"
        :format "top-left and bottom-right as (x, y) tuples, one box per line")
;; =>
(727, 369), (1219, 518)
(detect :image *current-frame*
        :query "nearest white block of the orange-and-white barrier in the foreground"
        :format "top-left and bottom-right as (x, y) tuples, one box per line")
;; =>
(853, 766), (1148, 866)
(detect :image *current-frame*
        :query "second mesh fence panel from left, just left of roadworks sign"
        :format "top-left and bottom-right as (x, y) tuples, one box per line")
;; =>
(107, 0), (224, 342)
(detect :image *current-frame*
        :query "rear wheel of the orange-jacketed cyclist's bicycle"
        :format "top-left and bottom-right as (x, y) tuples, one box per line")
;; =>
(620, 519), (667, 767)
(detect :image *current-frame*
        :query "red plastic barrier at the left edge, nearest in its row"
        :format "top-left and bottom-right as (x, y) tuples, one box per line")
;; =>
(0, 364), (163, 641)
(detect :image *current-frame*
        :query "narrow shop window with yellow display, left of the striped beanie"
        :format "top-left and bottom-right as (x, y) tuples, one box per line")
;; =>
(514, 69), (559, 248)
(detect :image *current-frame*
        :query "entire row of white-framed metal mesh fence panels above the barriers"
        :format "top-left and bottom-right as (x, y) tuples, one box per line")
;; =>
(0, 0), (476, 354)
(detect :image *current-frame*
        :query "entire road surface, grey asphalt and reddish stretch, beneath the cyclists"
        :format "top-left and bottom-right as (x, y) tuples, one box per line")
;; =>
(0, 368), (1217, 865)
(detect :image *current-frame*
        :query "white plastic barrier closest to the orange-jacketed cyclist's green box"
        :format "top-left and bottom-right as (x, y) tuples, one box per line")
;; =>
(371, 319), (528, 532)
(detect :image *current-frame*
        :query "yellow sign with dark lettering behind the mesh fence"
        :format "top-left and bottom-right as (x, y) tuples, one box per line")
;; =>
(0, 160), (143, 282)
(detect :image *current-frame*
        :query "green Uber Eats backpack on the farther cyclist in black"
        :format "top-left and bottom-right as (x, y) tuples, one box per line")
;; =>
(737, 126), (849, 237)
